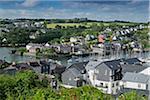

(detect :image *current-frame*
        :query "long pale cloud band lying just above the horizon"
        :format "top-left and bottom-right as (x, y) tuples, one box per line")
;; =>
(0, 6), (148, 21)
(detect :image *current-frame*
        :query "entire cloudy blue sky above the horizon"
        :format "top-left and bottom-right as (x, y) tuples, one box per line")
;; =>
(0, 0), (150, 22)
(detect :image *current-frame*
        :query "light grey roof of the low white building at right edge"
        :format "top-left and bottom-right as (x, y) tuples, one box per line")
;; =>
(122, 72), (150, 84)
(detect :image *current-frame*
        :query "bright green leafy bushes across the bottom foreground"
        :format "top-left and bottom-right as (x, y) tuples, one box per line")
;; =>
(0, 71), (147, 100)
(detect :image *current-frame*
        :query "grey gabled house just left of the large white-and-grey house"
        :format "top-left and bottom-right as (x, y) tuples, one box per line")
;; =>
(62, 62), (88, 88)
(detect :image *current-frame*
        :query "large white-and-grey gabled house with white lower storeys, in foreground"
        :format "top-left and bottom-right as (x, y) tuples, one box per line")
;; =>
(86, 60), (122, 94)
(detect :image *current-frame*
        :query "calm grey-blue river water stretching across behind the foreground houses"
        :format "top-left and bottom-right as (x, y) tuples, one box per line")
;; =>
(0, 47), (150, 66)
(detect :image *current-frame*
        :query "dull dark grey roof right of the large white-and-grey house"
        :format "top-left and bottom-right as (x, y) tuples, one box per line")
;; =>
(121, 64), (147, 73)
